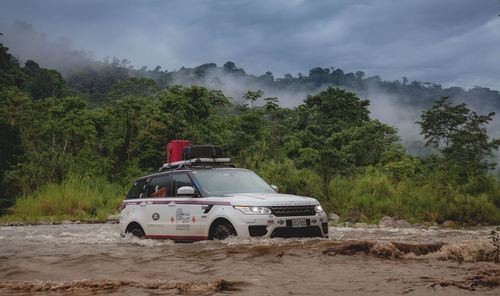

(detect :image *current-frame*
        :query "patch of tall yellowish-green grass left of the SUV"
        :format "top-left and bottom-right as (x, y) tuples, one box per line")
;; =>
(3, 176), (126, 221)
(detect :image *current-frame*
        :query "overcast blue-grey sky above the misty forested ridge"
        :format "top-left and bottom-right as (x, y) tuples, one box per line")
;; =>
(0, 0), (500, 90)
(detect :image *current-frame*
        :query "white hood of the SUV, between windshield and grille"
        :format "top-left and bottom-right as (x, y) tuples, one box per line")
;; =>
(220, 193), (318, 206)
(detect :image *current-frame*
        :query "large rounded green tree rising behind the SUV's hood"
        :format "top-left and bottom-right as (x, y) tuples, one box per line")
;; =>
(285, 87), (376, 197)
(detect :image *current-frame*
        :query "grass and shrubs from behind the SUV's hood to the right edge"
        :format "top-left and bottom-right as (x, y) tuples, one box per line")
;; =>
(258, 160), (500, 224)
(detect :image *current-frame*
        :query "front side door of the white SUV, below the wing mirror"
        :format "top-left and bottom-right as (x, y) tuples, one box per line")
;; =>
(171, 172), (207, 239)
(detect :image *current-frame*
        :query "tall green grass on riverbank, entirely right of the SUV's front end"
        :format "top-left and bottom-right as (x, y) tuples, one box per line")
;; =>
(328, 168), (500, 224)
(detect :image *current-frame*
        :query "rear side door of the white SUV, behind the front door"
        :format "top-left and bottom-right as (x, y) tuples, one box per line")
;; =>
(143, 174), (175, 237)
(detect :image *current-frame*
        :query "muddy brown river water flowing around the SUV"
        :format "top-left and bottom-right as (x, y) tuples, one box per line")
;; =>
(0, 224), (500, 295)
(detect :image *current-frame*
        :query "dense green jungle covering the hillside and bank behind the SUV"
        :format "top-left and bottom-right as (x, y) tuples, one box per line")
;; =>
(0, 39), (500, 224)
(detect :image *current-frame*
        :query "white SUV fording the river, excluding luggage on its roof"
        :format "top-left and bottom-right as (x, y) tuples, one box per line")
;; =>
(120, 159), (328, 241)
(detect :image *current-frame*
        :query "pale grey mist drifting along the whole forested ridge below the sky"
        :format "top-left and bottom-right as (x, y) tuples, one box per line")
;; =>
(0, 22), (500, 156)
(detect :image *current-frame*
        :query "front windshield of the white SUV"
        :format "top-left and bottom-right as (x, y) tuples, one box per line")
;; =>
(193, 170), (275, 195)
